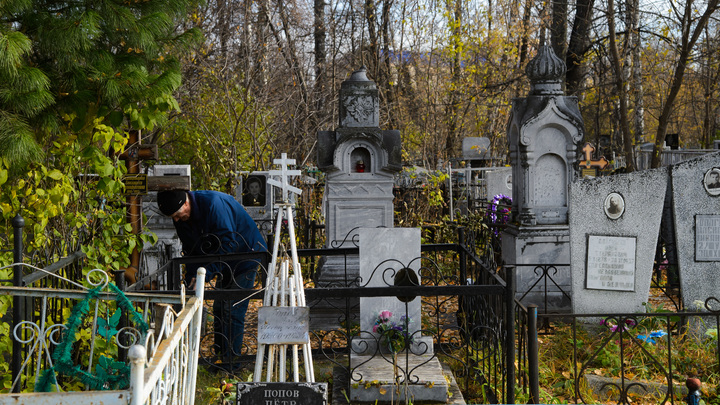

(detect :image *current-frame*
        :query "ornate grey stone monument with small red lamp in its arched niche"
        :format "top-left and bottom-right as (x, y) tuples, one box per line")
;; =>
(317, 67), (401, 286)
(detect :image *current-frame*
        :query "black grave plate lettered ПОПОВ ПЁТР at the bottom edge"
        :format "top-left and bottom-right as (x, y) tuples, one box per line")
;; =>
(236, 382), (328, 405)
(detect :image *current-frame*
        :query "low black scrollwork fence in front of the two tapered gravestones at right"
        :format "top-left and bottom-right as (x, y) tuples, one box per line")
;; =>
(539, 304), (720, 404)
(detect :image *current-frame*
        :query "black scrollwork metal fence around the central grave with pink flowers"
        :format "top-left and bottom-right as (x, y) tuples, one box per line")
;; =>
(124, 228), (529, 403)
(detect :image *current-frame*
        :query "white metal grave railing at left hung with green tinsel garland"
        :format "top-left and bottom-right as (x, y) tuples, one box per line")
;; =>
(0, 263), (205, 405)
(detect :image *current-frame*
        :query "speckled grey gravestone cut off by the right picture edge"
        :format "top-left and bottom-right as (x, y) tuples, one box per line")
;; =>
(670, 152), (720, 310)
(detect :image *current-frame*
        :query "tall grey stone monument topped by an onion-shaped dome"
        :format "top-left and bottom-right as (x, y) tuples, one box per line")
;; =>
(502, 46), (585, 311)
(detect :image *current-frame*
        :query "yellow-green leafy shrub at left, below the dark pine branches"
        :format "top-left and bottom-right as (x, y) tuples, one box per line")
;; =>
(0, 123), (156, 271)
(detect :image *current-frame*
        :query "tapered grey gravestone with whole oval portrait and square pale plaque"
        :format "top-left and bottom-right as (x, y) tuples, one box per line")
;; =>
(569, 168), (668, 314)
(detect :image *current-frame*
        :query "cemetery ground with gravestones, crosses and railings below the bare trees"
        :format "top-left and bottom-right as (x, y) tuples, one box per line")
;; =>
(0, 19), (720, 405)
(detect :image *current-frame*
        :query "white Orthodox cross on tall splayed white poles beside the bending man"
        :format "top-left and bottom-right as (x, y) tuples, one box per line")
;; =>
(253, 153), (315, 382)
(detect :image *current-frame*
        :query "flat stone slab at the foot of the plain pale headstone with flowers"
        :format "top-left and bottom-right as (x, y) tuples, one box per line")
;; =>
(350, 353), (449, 403)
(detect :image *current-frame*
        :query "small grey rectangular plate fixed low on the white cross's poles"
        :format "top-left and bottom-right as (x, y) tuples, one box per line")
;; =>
(258, 307), (310, 345)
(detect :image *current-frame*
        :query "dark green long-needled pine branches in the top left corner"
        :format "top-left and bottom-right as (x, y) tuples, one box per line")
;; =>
(0, 0), (200, 176)
